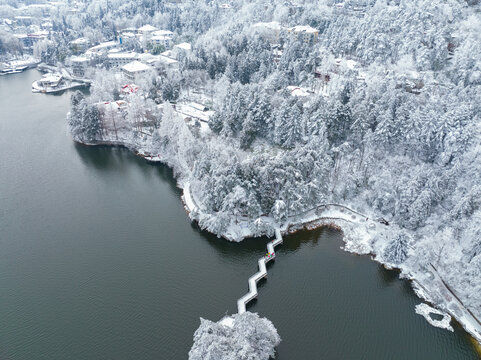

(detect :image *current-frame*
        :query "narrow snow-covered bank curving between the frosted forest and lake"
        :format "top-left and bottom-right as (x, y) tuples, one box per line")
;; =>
(74, 139), (481, 351)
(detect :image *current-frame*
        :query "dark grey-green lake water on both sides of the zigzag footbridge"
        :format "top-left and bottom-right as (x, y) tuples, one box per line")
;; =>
(0, 70), (478, 360)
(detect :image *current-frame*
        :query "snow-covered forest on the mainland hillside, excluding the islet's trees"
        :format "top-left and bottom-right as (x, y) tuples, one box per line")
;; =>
(5, 0), (481, 352)
